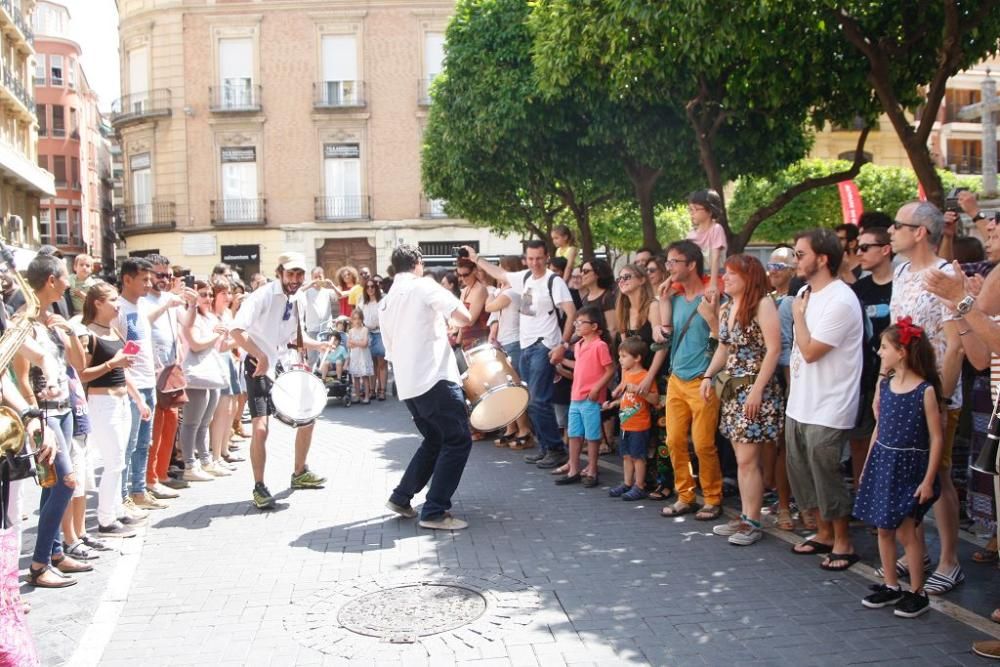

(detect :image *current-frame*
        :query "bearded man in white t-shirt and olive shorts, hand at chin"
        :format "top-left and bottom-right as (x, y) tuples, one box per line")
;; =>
(785, 229), (864, 571)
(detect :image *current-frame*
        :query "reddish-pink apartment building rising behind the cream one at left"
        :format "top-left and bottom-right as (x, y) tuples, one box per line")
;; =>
(33, 0), (110, 258)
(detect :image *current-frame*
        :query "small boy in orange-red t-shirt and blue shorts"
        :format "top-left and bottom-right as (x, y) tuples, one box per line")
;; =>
(604, 337), (659, 500)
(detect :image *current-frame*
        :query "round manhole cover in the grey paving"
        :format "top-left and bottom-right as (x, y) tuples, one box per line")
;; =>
(337, 584), (486, 639)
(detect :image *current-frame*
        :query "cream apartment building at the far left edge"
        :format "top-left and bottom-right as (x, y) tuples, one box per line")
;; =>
(0, 0), (55, 246)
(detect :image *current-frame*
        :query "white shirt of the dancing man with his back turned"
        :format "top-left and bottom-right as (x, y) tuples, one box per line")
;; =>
(379, 272), (462, 400)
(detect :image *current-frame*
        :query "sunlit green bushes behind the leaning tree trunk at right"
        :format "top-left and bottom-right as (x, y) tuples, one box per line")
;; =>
(729, 159), (981, 243)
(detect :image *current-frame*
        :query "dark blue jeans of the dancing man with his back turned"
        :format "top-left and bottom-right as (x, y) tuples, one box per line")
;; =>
(389, 380), (472, 520)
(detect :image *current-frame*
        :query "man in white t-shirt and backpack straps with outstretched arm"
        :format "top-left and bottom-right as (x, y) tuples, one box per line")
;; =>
(464, 240), (576, 469)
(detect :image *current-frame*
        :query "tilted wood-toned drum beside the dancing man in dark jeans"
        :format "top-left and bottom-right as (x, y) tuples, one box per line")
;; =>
(462, 344), (528, 432)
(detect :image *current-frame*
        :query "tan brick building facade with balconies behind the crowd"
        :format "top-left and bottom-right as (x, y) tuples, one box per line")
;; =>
(111, 0), (520, 276)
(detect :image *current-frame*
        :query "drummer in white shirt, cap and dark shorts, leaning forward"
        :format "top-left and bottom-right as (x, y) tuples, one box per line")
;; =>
(230, 252), (328, 509)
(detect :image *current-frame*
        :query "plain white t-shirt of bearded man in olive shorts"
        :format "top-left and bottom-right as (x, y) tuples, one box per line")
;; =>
(785, 280), (864, 429)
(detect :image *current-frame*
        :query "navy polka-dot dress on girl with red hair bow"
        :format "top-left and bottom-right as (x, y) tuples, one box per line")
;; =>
(854, 380), (940, 529)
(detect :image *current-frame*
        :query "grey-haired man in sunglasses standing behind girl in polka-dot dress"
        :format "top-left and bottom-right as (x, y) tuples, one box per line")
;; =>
(889, 202), (965, 595)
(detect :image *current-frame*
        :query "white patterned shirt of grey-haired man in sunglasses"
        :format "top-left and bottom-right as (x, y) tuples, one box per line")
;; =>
(889, 259), (962, 409)
